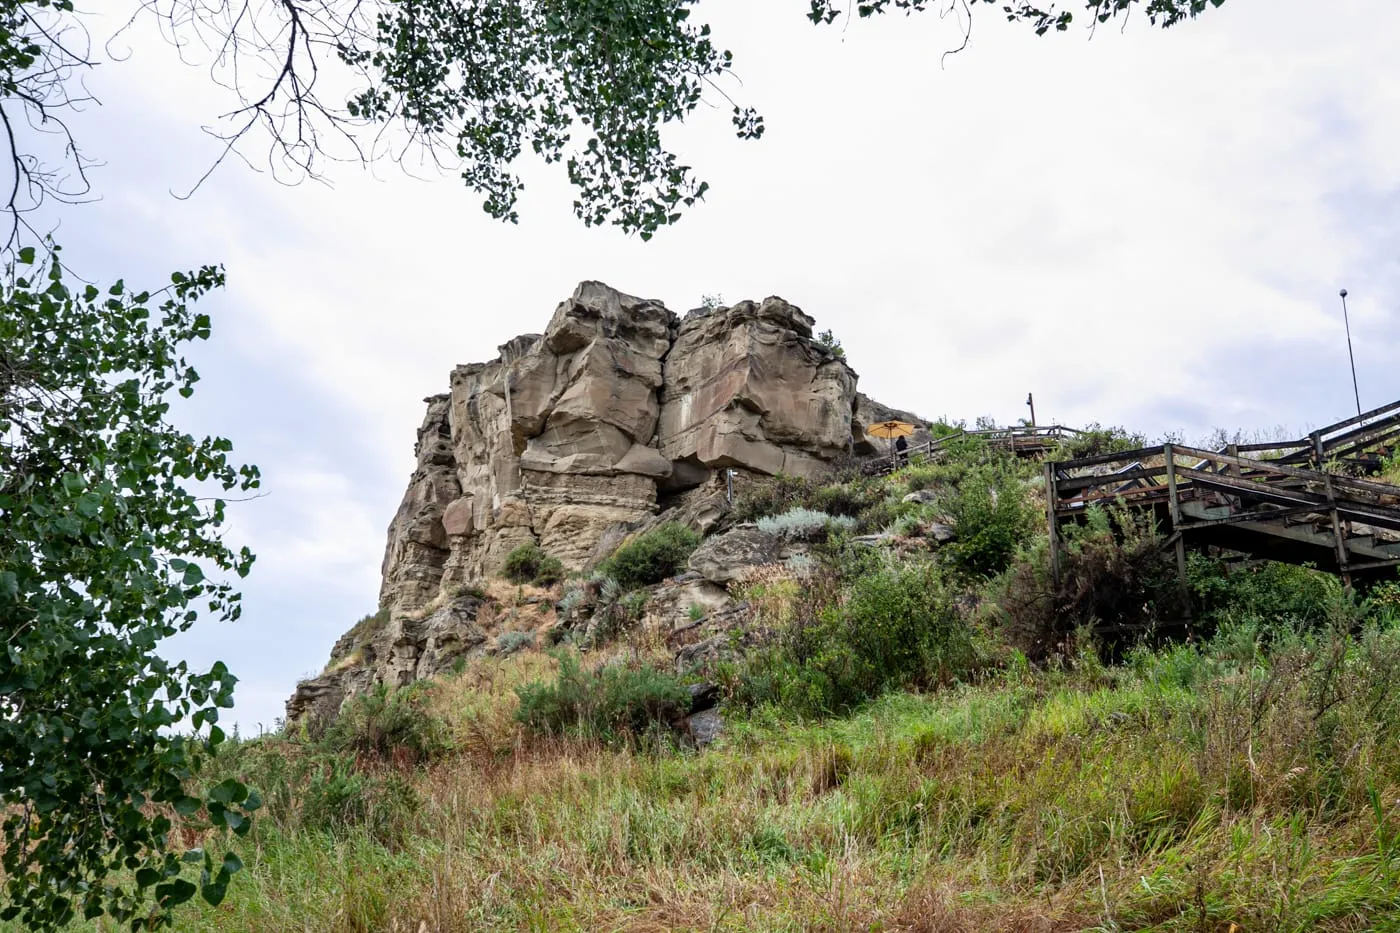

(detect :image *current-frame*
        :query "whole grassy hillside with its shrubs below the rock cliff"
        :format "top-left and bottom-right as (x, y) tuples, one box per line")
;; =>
(24, 436), (1400, 933)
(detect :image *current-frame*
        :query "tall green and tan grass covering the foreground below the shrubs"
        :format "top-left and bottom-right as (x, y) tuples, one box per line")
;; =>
(19, 626), (1400, 933)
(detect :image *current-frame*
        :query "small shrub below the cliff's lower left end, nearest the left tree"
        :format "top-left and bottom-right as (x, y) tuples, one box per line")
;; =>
(326, 681), (452, 763)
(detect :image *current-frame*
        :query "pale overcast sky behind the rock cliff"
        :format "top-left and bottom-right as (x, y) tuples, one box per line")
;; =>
(32, 0), (1400, 733)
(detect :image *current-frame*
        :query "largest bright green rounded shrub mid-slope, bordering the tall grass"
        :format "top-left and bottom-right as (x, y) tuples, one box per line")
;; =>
(735, 562), (977, 716)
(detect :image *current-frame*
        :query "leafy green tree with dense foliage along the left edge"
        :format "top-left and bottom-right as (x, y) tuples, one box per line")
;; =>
(0, 247), (259, 929)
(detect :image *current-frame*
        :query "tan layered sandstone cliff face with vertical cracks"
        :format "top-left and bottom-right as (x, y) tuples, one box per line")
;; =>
(287, 282), (897, 721)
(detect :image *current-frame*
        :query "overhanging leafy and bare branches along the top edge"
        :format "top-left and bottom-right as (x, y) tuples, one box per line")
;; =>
(0, 0), (1224, 238)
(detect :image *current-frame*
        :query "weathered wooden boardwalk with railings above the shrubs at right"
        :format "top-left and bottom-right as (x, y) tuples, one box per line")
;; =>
(1044, 402), (1400, 586)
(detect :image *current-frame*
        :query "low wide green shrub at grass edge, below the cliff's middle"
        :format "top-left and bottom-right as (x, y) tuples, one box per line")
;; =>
(515, 654), (690, 741)
